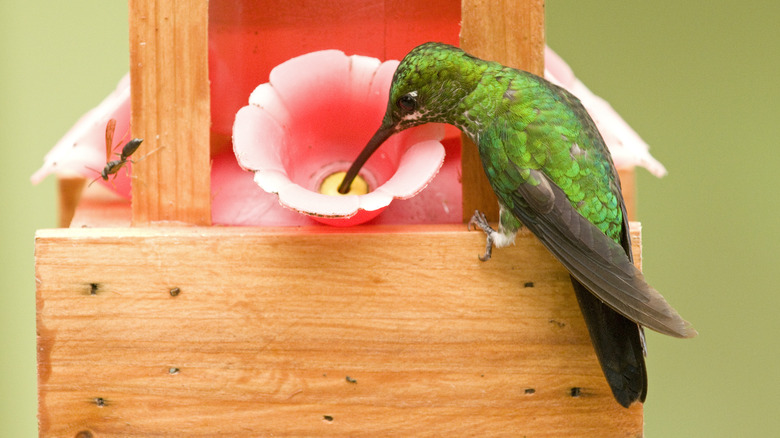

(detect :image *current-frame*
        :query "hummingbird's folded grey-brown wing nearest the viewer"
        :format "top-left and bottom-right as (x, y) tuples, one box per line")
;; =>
(510, 165), (696, 338)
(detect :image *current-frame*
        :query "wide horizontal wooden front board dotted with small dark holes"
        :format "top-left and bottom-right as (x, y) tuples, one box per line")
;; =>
(36, 225), (642, 437)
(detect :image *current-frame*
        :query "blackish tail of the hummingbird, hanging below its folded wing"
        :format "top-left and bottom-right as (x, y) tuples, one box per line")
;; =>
(571, 277), (647, 408)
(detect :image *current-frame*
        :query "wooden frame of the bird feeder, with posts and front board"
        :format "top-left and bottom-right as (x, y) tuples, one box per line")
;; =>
(35, 0), (642, 437)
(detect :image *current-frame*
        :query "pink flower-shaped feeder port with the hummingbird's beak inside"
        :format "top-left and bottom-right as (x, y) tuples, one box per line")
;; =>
(233, 50), (448, 225)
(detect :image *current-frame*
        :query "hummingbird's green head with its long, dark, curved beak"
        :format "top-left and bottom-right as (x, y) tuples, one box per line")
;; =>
(339, 43), (485, 193)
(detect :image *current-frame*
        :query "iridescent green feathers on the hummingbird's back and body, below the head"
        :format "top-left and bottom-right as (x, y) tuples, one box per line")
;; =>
(449, 59), (623, 242)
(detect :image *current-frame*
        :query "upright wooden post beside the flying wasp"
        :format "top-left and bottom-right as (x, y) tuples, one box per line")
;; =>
(130, 0), (211, 225)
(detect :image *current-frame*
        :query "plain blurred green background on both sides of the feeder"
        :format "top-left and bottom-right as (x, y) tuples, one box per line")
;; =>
(0, 0), (780, 437)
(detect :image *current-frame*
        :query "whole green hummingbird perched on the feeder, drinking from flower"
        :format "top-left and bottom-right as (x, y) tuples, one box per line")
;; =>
(339, 43), (697, 407)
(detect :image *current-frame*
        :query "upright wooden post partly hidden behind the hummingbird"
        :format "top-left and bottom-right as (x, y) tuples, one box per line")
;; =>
(460, 0), (544, 222)
